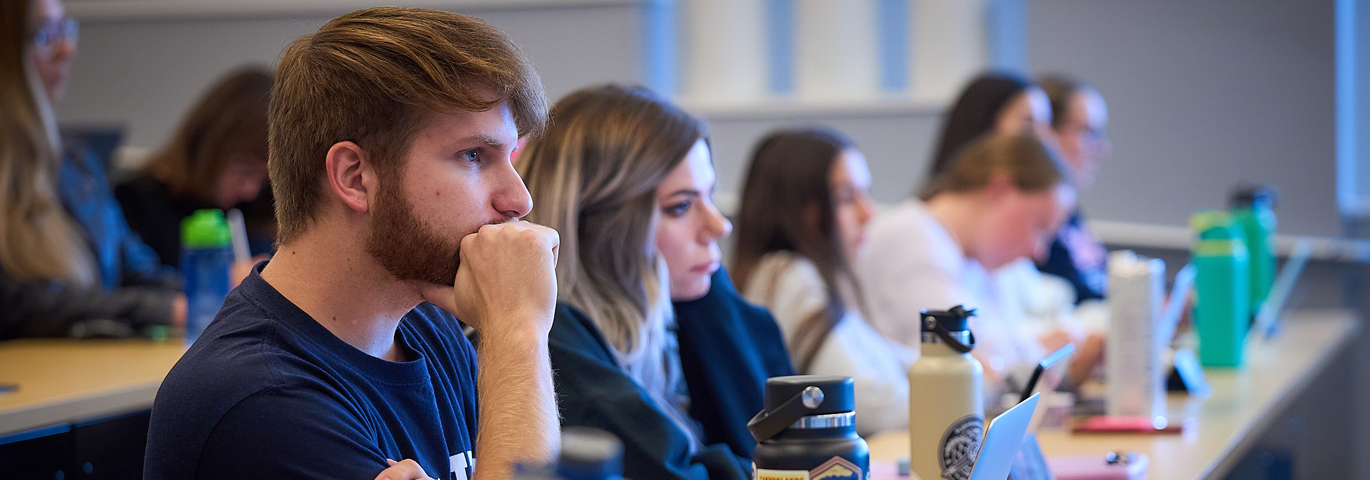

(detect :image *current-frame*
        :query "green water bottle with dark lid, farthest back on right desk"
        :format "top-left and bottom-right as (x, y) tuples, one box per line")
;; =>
(1230, 187), (1275, 314)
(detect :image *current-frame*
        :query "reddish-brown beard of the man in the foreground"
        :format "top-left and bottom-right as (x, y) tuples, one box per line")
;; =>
(366, 179), (465, 285)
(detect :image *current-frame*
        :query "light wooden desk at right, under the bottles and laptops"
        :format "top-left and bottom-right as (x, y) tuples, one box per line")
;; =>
(867, 311), (1359, 480)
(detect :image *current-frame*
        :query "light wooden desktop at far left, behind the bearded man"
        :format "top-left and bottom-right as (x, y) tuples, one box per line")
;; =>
(0, 339), (185, 435)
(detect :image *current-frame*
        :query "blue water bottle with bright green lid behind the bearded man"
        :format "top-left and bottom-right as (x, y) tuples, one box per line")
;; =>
(181, 210), (233, 344)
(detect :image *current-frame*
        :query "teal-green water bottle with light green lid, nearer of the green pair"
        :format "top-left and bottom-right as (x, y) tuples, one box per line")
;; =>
(1189, 210), (1251, 368)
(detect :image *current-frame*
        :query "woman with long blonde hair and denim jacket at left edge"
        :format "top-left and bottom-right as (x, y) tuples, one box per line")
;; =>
(0, 0), (185, 339)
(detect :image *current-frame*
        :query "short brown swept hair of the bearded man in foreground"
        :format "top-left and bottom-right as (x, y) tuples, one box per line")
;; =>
(269, 7), (547, 244)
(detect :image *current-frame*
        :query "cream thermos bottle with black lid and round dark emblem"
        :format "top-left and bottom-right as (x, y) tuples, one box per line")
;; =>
(908, 306), (985, 480)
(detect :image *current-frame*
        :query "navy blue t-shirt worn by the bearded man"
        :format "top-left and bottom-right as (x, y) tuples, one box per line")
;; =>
(144, 262), (477, 480)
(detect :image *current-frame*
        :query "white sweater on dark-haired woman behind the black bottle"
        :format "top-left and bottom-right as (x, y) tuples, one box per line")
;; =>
(745, 252), (917, 436)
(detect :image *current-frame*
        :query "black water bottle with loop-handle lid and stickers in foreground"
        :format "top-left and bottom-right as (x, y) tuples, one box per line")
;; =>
(747, 376), (870, 480)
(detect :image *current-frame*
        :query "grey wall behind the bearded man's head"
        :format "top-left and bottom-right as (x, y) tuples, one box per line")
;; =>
(56, 3), (641, 148)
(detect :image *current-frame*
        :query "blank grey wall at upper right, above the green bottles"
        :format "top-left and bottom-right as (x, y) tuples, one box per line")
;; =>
(1029, 0), (1340, 236)
